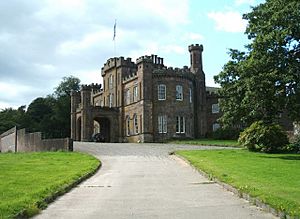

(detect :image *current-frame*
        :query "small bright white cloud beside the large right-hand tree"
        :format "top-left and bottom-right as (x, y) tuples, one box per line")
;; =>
(208, 11), (247, 33)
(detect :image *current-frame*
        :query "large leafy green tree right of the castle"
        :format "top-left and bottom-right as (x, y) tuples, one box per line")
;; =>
(215, 0), (300, 126)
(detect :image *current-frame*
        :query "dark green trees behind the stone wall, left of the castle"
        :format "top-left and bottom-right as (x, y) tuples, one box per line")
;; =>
(0, 76), (80, 138)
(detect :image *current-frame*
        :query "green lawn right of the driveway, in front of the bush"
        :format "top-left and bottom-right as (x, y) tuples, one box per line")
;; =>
(176, 150), (300, 217)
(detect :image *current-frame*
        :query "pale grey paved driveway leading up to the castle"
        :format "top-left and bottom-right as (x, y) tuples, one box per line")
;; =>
(36, 143), (275, 219)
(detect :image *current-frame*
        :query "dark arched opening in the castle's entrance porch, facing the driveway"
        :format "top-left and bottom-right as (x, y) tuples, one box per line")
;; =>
(94, 117), (111, 142)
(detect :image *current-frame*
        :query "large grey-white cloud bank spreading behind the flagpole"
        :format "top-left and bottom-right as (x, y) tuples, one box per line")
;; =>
(0, 0), (190, 108)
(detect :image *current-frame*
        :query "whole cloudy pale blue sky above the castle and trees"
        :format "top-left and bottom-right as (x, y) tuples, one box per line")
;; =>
(0, 0), (264, 110)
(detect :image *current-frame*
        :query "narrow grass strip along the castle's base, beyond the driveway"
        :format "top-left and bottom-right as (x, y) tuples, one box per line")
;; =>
(170, 138), (239, 147)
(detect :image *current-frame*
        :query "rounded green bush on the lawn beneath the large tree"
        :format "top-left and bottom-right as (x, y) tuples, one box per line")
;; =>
(238, 121), (289, 153)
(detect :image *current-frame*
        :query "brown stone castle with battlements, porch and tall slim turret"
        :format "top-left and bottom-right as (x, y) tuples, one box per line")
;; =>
(71, 44), (220, 142)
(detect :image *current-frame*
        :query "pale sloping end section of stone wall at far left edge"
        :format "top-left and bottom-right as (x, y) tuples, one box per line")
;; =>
(0, 127), (17, 152)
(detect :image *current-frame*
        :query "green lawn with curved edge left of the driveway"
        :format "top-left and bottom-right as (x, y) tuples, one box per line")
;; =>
(0, 152), (100, 218)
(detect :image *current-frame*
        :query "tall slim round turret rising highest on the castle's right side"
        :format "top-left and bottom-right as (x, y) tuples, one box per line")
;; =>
(189, 44), (207, 138)
